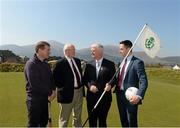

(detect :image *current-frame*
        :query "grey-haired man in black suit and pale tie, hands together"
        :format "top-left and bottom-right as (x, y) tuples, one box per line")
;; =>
(84, 43), (115, 127)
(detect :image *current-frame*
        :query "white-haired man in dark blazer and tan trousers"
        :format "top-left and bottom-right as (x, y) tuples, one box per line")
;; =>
(53, 44), (83, 127)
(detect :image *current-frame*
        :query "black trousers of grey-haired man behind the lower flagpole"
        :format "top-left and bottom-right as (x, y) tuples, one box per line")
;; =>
(87, 93), (111, 127)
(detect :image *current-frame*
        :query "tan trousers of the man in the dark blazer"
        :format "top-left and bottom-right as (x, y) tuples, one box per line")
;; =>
(59, 87), (83, 127)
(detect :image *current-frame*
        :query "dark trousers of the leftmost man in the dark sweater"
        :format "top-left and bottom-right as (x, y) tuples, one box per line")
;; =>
(26, 99), (48, 127)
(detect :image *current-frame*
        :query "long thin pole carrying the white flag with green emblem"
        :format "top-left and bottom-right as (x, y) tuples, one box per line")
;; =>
(82, 23), (147, 127)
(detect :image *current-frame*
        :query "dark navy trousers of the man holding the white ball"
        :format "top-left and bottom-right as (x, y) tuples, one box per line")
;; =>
(116, 91), (138, 127)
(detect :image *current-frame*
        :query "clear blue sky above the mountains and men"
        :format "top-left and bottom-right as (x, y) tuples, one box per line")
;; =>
(0, 0), (180, 56)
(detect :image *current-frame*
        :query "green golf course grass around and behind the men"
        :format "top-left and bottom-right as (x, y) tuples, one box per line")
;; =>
(0, 68), (180, 127)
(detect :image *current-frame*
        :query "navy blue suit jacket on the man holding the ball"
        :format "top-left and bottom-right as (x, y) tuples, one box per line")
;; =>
(110, 56), (148, 98)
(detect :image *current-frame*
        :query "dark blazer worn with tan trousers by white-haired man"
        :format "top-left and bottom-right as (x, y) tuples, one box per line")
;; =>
(53, 57), (82, 103)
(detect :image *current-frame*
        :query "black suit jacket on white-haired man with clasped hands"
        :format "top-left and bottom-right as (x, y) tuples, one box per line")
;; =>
(84, 58), (115, 101)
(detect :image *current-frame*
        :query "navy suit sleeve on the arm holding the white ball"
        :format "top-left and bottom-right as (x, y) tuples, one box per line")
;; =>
(136, 61), (148, 99)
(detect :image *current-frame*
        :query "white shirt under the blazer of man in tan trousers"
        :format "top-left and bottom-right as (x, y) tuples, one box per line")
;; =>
(65, 56), (81, 87)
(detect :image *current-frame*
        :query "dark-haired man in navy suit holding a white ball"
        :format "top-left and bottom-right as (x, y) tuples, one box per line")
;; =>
(110, 40), (148, 127)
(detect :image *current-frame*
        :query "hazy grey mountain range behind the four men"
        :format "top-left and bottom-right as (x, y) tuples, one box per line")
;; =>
(0, 40), (180, 65)
